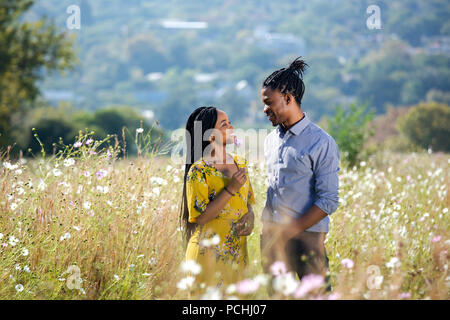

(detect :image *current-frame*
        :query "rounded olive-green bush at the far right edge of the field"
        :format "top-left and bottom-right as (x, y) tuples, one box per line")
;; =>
(397, 102), (450, 152)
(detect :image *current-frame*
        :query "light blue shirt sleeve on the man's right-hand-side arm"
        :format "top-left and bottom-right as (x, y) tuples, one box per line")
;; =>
(313, 136), (340, 215)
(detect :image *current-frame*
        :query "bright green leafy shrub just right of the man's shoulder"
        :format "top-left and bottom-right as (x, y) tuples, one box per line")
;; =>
(325, 103), (374, 167)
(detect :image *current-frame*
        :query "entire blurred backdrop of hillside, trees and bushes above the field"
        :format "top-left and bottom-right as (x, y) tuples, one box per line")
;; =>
(0, 0), (450, 162)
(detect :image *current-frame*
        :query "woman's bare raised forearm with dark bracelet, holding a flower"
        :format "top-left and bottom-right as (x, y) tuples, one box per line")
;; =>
(195, 168), (247, 225)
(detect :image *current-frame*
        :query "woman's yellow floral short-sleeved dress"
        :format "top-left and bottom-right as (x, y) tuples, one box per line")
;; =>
(186, 155), (255, 285)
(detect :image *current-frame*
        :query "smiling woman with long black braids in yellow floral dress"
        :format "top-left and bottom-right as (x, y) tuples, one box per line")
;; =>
(181, 107), (255, 285)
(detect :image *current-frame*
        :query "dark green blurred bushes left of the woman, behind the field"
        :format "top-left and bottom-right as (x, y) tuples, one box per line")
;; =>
(24, 104), (167, 157)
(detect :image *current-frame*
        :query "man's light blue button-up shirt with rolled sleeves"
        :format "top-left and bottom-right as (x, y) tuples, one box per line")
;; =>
(262, 112), (340, 232)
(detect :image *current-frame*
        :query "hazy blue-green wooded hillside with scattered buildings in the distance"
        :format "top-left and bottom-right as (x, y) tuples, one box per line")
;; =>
(26, 0), (450, 129)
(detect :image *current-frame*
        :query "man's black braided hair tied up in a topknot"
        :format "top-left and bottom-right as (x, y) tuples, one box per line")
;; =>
(263, 57), (308, 105)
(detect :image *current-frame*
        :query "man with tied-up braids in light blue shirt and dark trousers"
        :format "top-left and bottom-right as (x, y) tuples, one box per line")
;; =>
(261, 58), (340, 290)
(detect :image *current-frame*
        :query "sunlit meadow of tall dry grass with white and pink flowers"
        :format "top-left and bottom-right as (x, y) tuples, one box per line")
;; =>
(0, 131), (450, 299)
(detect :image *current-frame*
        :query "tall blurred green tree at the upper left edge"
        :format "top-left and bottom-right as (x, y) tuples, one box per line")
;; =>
(0, 0), (74, 152)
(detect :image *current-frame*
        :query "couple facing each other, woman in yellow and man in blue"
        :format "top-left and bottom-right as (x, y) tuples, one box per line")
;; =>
(181, 58), (340, 290)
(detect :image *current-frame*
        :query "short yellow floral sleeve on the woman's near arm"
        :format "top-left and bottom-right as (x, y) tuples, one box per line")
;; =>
(186, 166), (209, 223)
